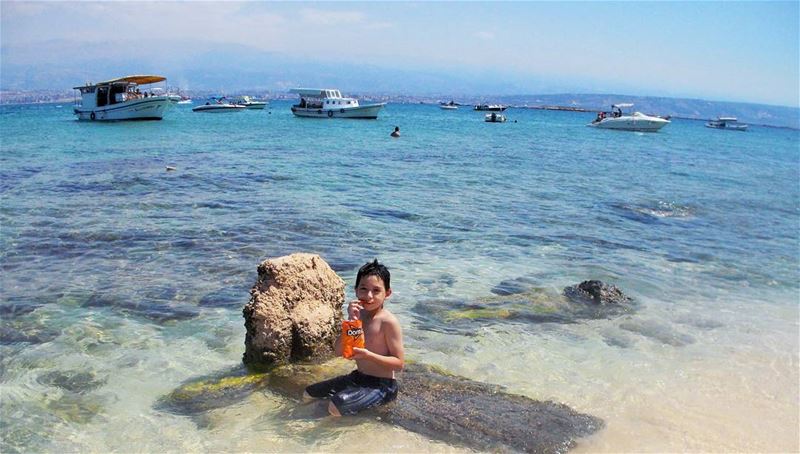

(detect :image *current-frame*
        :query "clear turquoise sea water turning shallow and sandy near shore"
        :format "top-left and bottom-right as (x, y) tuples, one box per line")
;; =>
(0, 101), (800, 453)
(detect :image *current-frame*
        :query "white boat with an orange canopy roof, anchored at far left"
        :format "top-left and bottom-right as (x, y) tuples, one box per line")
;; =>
(73, 75), (180, 121)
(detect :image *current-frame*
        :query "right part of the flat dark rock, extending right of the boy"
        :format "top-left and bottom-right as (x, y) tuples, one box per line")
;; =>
(378, 365), (604, 453)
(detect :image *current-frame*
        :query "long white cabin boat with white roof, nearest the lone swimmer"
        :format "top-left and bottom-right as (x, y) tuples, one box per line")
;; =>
(289, 88), (386, 119)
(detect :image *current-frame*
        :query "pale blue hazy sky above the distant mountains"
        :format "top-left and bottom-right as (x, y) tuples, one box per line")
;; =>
(0, 0), (800, 107)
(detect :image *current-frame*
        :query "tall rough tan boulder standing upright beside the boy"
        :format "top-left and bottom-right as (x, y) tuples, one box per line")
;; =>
(243, 254), (344, 366)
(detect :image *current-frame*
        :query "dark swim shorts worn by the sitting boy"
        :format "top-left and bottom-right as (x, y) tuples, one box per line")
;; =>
(306, 370), (398, 415)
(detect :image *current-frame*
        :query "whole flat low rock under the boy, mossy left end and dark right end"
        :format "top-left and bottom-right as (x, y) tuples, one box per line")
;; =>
(158, 359), (604, 453)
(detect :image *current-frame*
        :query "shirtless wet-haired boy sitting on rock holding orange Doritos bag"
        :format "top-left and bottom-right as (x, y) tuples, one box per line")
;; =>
(304, 259), (404, 416)
